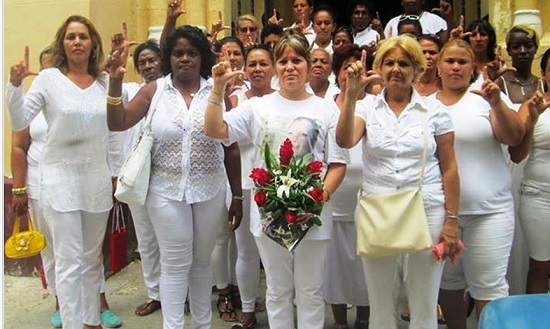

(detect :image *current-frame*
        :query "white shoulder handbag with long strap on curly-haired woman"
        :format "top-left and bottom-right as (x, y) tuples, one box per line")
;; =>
(115, 78), (164, 205)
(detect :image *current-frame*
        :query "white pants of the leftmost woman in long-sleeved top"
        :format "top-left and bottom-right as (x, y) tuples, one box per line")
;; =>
(43, 204), (109, 329)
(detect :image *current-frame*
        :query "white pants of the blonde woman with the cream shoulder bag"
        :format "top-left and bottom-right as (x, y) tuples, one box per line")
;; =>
(362, 207), (445, 329)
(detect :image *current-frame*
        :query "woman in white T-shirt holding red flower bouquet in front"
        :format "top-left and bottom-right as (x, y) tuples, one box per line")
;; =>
(204, 32), (346, 329)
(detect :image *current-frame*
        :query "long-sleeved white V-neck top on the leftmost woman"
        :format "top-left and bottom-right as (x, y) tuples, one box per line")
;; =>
(7, 68), (112, 212)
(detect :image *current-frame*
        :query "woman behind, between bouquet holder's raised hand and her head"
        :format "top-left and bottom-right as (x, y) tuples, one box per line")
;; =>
(229, 44), (275, 328)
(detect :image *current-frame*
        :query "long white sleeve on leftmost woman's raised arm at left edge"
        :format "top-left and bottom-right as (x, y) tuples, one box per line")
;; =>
(6, 72), (48, 131)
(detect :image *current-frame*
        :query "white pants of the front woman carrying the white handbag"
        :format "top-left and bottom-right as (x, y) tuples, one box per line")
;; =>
(146, 188), (227, 329)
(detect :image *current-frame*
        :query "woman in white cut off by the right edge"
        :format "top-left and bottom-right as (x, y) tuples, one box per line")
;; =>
(508, 49), (550, 294)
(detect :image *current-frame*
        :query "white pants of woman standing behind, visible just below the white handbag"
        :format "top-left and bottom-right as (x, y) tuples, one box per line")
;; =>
(128, 204), (160, 300)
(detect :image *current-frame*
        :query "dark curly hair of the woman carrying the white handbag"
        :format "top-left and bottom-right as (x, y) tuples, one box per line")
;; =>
(162, 25), (216, 79)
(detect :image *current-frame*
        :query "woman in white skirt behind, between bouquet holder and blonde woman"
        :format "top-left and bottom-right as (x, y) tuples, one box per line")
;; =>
(323, 44), (374, 329)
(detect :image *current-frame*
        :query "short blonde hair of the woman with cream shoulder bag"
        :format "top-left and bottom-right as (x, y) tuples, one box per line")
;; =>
(372, 35), (426, 81)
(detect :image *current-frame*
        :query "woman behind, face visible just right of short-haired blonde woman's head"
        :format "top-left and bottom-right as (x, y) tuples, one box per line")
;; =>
(414, 34), (443, 96)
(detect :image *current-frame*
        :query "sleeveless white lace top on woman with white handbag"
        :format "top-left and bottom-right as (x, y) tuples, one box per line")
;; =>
(149, 74), (227, 204)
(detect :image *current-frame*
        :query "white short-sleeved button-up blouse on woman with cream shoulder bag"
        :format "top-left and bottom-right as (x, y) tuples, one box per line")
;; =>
(355, 89), (453, 206)
